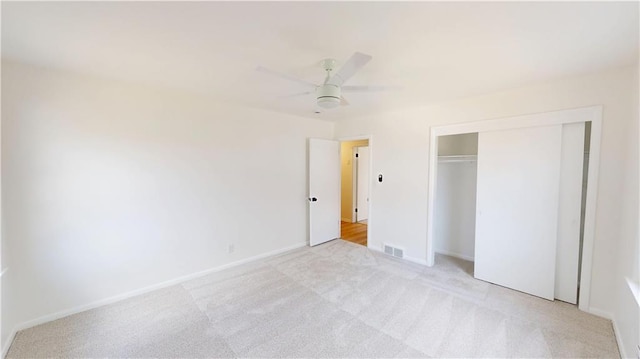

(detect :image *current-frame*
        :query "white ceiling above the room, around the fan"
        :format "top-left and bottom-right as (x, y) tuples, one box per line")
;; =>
(1, 1), (639, 120)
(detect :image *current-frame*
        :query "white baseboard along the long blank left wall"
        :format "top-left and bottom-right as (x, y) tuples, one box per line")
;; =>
(2, 242), (308, 358)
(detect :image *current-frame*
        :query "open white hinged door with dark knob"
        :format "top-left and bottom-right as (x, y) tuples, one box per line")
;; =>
(308, 138), (340, 246)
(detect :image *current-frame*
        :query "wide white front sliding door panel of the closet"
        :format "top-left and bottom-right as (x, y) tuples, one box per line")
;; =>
(475, 125), (562, 300)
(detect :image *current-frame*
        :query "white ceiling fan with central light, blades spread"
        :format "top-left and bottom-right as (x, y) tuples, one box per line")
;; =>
(256, 52), (396, 113)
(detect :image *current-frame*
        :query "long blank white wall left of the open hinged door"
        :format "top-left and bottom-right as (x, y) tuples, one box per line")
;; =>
(2, 62), (334, 350)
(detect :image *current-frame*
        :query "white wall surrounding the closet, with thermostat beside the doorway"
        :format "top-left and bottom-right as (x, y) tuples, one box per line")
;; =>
(336, 67), (638, 324)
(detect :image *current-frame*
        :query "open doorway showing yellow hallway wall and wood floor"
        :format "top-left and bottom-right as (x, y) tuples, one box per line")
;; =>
(340, 139), (371, 246)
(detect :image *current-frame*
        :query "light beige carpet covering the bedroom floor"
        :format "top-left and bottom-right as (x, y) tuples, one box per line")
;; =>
(8, 240), (620, 358)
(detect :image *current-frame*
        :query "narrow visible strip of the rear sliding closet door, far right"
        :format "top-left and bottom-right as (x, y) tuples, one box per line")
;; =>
(555, 122), (584, 304)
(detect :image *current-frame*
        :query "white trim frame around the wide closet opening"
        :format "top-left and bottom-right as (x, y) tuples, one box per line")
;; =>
(426, 105), (602, 312)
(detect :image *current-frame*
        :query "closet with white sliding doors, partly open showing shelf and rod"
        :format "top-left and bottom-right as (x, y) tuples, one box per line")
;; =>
(432, 114), (589, 304)
